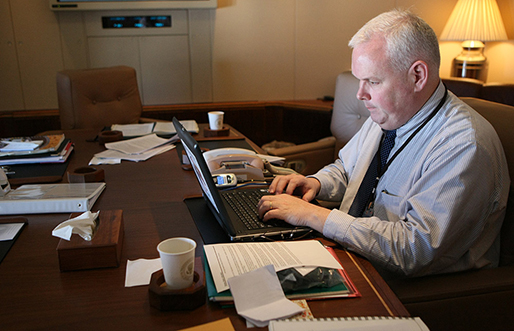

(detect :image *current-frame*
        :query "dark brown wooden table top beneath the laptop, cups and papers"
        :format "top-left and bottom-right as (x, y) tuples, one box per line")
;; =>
(0, 126), (408, 330)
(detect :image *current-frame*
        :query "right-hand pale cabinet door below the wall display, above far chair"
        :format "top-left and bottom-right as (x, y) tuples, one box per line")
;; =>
(140, 35), (193, 105)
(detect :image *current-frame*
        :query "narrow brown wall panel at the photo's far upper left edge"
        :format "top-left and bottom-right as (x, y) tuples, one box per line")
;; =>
(0, 0), (23, 110)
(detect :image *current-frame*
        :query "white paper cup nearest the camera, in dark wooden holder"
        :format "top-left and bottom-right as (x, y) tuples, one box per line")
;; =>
(157, 237), (196, 290)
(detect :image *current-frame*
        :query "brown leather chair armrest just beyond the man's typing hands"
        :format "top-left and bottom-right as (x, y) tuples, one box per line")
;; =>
(268, 137), (336, 175)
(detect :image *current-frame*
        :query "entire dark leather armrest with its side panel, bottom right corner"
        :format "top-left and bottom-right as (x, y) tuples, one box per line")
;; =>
(387, 266), (514, 331)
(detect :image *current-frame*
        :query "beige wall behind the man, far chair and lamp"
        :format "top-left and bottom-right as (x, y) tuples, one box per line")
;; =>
(5, 0), (514, 111)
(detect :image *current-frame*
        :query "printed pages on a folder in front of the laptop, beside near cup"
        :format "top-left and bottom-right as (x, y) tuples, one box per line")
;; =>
(204, 240), (360, 302)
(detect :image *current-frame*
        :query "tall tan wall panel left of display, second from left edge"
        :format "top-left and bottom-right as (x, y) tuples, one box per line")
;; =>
(10, 0), (63, 109)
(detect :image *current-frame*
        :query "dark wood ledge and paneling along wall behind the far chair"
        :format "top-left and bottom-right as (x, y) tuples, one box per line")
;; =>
(0, 100), (332, 146)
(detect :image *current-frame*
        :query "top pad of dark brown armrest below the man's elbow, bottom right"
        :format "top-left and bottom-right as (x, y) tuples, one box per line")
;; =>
(387, 266), (514, 304)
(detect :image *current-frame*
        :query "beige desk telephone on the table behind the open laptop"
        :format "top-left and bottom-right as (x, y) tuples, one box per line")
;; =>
(203, 148), (295, 182)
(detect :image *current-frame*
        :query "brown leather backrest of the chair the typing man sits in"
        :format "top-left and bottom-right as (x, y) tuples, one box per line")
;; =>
(462, 98), (514, 265)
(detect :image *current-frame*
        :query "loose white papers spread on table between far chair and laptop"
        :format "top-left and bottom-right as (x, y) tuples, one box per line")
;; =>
(89, 133), (178, 165)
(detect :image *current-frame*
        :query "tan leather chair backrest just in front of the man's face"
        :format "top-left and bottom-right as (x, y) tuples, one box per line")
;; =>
(330, 71), (369, 159)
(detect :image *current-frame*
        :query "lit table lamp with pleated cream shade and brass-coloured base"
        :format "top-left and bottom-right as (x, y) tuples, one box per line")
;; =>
(440, 0), (508, 82)
